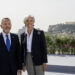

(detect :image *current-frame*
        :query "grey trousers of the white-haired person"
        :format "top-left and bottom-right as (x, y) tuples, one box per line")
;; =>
(26, 53), (44, 75)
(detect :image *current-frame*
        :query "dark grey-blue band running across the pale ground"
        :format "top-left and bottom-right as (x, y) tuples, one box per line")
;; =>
(47, 65), (75, 74)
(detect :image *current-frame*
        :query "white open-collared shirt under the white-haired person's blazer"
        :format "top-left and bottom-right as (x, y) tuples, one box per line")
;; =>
(25, 29), (33, 52)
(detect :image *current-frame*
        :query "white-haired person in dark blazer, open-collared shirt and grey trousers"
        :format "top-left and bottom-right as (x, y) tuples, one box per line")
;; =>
(21, 16), (47, 75)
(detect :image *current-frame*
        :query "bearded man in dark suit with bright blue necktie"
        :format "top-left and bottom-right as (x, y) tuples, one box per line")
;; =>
(0, 18), (22, 75)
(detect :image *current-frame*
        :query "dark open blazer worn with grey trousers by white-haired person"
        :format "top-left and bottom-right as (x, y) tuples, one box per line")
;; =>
(21, 29), (47, 65)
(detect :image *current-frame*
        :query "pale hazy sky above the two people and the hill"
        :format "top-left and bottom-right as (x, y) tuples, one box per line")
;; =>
(0, 0), (75, 33)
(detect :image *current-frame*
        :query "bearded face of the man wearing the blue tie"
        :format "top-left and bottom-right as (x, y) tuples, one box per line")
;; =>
(1, 19), (11, 34)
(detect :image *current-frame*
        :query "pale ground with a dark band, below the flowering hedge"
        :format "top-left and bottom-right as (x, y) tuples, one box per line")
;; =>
(23, 55), (75, 75)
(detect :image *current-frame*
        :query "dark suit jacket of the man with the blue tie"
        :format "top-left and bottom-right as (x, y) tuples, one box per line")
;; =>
(0, 33), (22, 75)
